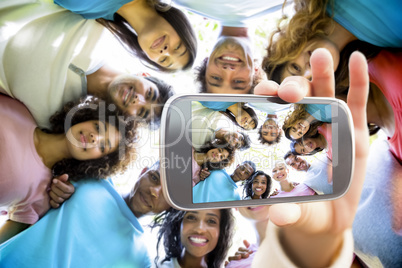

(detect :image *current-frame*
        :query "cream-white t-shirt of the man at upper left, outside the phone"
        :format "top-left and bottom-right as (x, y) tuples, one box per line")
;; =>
(0, 0), (107, 127)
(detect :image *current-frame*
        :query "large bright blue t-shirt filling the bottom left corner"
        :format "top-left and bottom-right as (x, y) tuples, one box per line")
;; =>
(0, 180), (151, 268)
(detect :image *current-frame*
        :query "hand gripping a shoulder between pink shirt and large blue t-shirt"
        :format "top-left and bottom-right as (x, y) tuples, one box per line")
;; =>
(49, 174), (75, 208)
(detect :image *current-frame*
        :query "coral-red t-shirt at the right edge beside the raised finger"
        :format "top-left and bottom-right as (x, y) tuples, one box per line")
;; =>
(368, 50), (402, 164)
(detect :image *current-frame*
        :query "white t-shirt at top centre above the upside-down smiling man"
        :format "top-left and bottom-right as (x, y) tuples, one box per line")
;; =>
(173, 0), (292, 27)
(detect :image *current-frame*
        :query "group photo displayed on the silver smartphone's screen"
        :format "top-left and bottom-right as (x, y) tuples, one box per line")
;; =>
(188, 101), (334, 203)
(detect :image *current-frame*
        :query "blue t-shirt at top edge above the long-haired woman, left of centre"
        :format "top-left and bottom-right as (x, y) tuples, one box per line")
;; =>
(54, 0), (133, 20)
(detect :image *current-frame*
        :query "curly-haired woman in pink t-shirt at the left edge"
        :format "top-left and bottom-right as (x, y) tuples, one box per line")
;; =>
(0, 95), (136, 244)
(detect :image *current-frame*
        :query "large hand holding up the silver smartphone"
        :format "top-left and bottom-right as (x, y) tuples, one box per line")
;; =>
(253, 49), (369, 267)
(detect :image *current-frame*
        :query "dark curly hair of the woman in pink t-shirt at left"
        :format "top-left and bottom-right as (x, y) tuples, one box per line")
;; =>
(48, 97), (137, 181)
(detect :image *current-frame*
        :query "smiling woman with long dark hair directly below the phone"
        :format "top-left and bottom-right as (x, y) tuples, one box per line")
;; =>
(155, 209), (234, 268)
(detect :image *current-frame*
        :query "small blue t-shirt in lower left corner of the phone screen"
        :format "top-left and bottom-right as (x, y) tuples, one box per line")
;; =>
(193, 170), (241, 203)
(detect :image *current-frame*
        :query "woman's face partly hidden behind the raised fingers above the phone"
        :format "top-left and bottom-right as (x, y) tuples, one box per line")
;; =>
(281, 38), (339, 81)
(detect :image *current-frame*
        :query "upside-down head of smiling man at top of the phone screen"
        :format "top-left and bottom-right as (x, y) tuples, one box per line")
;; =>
(258, 114), (282, 145)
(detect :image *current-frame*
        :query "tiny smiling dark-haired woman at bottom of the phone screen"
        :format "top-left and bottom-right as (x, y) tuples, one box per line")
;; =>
(243, 170), (272, 199)
